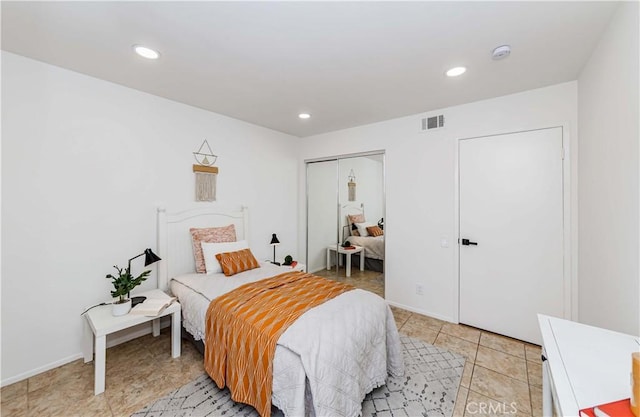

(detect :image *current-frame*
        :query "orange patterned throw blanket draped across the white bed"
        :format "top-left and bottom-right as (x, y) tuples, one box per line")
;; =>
(204, 272), (354, 417)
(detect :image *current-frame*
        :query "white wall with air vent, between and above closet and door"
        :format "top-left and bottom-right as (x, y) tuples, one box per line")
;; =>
(299, 82), (577, 321)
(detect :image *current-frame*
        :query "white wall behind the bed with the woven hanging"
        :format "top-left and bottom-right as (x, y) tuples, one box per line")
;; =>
(1, 52), (298, 385)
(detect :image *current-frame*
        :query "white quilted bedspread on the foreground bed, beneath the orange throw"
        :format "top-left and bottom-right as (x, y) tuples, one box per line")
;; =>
(171, 264), (404, 417)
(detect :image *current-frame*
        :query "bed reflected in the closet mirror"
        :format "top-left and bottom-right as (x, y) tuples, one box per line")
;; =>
(341, 202), (384, 272)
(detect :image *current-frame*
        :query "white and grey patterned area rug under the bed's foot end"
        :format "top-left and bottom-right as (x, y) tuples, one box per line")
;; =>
(132, 335), (464, 417)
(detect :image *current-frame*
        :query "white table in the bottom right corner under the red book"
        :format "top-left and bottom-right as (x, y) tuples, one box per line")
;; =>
(538, 314), (640, 416)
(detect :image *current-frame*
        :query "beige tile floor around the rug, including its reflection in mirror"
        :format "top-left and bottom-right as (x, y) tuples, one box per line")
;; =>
(0, 270), (542, 417)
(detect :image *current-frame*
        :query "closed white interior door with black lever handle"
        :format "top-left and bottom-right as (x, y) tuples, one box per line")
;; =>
(459, 127), (564, 344)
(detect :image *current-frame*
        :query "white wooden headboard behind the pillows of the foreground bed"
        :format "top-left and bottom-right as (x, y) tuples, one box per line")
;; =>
(157, 206), (249, 291)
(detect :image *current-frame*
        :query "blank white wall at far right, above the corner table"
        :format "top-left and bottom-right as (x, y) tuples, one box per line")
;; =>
(578, 2), (640, 334)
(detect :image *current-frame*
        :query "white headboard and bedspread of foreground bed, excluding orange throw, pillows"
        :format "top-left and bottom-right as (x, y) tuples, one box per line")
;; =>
(158, 206), (404, 416)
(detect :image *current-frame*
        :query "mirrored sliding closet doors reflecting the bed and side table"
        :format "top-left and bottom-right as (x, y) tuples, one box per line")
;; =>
(305, 151), (385, 297)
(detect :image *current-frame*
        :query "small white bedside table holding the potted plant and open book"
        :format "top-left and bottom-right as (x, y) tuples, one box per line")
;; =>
(82, 290), (180, 395)
